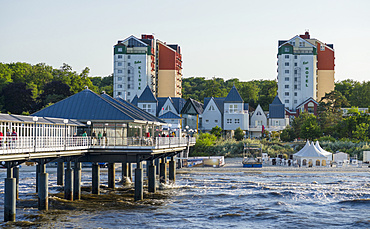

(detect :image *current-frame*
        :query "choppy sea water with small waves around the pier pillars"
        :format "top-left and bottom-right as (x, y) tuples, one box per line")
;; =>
(0, 160), (370, 228)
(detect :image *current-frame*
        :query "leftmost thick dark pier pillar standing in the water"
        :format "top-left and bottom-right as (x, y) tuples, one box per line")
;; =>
(4, 178), (16, 222)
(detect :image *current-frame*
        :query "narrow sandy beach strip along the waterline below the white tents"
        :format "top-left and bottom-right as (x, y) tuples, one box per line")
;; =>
(176, 158), (370, 174)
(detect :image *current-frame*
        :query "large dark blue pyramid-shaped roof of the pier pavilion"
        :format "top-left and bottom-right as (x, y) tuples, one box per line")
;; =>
(33, 89), (161, 121)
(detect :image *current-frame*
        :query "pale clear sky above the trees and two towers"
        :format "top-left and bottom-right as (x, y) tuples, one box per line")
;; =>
(0, 0), (370, 81)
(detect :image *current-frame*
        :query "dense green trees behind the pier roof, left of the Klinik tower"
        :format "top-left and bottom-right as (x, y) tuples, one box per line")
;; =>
(0, 62), (113, 114)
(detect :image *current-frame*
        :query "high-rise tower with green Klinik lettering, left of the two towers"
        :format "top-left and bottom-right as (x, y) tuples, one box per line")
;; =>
(113, 35), (182, 101)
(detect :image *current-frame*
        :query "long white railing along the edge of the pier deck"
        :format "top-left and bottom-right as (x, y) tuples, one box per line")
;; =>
(0, 137), (196, 155)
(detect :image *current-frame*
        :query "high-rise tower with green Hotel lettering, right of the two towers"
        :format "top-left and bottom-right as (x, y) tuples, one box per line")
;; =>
(278, 32), (335, 110)
